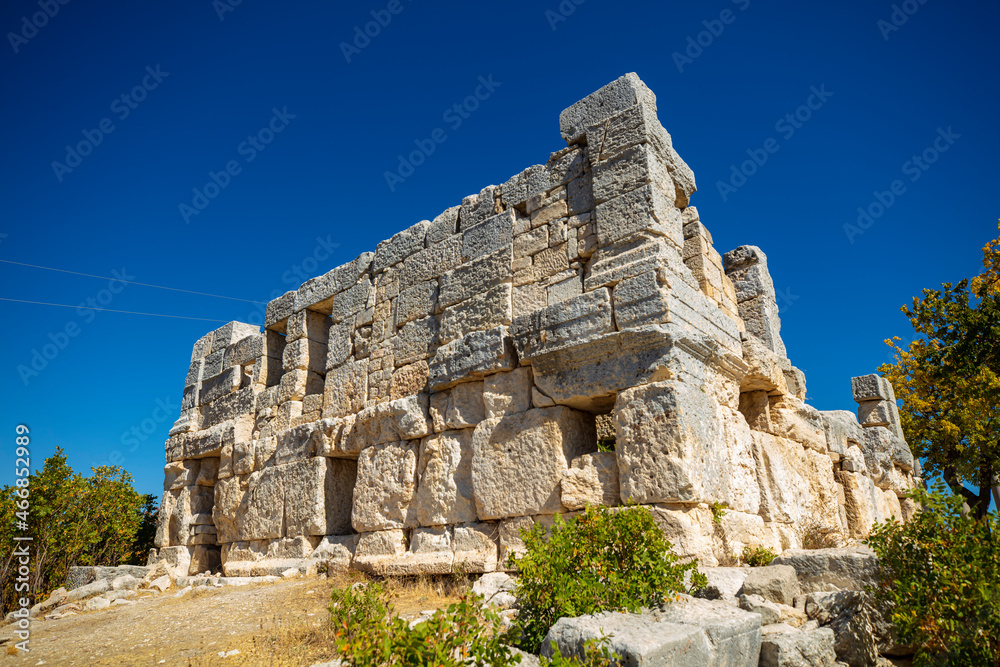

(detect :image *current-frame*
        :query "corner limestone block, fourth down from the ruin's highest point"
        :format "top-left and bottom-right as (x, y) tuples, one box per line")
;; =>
(595, 184), (684, 251)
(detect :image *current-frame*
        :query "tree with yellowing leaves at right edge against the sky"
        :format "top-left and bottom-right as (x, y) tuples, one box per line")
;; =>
(879, 222), (1000, 519)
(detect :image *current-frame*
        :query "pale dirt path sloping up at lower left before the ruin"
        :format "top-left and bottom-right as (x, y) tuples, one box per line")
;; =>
(0, 578), (454, 667)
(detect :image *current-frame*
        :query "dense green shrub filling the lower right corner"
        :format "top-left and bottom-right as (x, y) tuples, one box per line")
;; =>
(868, 486), (1000, 666)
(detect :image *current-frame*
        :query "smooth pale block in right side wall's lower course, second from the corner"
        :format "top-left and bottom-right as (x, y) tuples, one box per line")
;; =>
(751, 431), (810, 523)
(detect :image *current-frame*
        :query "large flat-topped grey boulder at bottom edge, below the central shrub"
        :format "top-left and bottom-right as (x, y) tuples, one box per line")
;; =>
(542, 596), (761, 667)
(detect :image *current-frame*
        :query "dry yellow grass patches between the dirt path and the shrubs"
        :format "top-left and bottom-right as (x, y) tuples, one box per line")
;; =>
(187, 573), (472, 667)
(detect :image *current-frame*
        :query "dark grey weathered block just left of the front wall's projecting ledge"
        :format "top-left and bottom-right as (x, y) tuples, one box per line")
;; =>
(428, 327), (517, 391)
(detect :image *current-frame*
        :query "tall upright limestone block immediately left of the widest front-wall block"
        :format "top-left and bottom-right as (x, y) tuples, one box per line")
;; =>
(411, 429), (476, 526)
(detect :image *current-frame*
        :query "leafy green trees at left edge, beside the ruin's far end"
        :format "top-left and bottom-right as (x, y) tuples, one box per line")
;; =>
(0, 448), (156, 612)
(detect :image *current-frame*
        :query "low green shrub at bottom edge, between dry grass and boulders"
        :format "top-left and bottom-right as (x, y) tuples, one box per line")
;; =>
(330, 582), (521, 667)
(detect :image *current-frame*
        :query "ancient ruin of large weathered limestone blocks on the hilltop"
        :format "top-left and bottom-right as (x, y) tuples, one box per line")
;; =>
(155, 74), (920, 576)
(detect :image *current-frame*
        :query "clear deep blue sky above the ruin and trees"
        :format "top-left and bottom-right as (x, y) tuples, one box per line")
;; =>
(0, 0), (1000, 494)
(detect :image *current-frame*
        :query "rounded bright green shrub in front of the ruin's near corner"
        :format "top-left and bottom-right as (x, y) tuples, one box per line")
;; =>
(508, 506), (707, 653)
